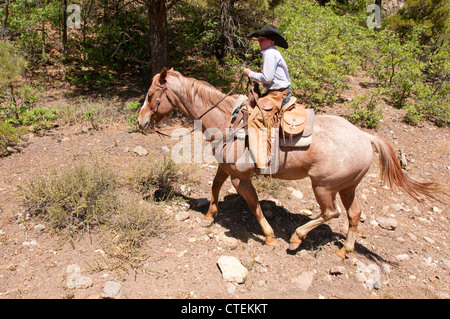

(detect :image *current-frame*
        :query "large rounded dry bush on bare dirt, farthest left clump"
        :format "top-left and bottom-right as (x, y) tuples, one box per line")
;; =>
(21, 161), (118, 234)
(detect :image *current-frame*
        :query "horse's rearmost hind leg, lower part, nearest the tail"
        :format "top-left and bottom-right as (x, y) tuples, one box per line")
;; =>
(336, 186), (361, 259)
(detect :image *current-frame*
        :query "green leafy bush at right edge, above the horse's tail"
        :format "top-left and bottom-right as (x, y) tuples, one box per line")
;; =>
(369, 27), (450, 126)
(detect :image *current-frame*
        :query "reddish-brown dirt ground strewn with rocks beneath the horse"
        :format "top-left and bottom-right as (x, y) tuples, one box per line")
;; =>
(0, 79), (450, 299)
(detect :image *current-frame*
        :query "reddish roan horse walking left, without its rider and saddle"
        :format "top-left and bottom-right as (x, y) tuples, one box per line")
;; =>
(138, 68), (440, 258)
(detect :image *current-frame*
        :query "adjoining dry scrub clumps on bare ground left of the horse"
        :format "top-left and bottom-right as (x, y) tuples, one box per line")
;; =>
(20, 160), (170, 263)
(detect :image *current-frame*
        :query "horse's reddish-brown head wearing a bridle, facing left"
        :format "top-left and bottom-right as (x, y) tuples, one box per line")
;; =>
(138, 68), (175, 129)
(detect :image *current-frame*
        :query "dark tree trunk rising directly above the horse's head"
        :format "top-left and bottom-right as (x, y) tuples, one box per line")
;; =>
(146, 0), (169, 76)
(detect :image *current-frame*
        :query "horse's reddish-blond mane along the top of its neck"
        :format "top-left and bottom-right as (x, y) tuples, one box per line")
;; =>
(170, 70), (234, 114)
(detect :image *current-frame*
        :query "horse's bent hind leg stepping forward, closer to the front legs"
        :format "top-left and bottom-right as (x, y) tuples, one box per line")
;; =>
(288, 186), (339, 250)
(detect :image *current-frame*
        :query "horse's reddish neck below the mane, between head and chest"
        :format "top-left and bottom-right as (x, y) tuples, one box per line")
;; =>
(169, 77), (232, 130)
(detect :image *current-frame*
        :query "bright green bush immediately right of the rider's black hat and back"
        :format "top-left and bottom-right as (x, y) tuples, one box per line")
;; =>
(278, 1), (371, 108)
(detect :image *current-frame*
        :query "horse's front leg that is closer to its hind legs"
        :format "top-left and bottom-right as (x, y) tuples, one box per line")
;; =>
(231, 177), (276, 246)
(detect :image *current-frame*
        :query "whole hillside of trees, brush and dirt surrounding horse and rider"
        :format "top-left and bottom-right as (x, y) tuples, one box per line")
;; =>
(0, 0), (450, 302)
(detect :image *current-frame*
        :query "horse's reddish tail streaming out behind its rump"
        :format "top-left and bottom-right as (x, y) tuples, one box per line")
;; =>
(370, 135), (443, 202)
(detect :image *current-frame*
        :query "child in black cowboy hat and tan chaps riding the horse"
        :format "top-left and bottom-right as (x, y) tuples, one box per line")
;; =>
(243, 24), (291, 168)
